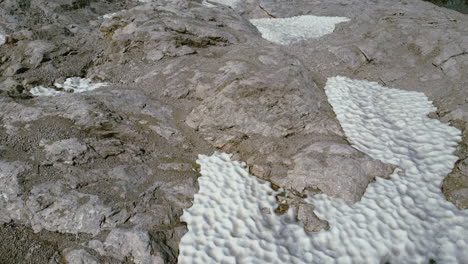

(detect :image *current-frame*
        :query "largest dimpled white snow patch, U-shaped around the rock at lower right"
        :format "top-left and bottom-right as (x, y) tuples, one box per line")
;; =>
(179, 77), (468, 264)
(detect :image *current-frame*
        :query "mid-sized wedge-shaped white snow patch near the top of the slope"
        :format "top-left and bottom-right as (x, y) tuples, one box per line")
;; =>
(250, 16), (349, 45)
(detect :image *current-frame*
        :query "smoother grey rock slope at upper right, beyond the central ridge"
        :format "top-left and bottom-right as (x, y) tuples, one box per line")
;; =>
(252, 0), (468, 209)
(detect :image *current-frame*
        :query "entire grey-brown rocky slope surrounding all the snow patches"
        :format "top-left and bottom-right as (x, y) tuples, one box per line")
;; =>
(0, 0), (468, 263)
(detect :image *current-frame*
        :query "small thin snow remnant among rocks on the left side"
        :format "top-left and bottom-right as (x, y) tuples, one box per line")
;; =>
(30, 77), (107, 96)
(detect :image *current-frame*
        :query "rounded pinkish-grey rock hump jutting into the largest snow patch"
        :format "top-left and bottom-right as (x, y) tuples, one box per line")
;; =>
(278, 142), (392, 203)
